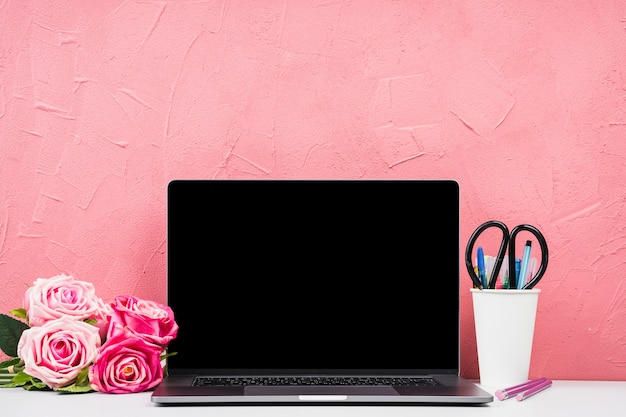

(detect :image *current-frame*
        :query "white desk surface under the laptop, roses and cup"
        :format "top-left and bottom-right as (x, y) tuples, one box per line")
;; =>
(0, 381), (626, 417)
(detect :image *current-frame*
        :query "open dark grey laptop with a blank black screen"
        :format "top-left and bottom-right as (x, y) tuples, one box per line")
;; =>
(151, 179), (493, 405)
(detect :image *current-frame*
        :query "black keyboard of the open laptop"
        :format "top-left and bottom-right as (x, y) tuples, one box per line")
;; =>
(193, 377), (441, 387)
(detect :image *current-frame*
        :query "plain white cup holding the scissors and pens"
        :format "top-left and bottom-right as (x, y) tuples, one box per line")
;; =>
(470, 288), (541, 389)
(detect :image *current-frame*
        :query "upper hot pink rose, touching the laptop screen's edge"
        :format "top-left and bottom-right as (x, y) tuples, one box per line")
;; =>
(107, 296), (178, 348)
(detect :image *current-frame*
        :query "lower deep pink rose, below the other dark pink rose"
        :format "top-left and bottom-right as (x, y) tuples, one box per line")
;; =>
(89, 331), (163, 394)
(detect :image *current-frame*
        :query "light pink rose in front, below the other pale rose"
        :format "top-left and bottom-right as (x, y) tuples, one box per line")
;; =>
(17, 317), (101, 388)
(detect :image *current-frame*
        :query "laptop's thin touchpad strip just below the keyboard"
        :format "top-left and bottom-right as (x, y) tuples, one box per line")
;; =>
(244, 385), (399, 396)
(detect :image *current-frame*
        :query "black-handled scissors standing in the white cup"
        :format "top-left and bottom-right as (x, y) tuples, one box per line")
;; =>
(465, 220), (548, 290)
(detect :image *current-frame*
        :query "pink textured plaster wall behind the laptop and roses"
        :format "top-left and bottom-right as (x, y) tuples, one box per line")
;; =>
(0, 0), (626, 379)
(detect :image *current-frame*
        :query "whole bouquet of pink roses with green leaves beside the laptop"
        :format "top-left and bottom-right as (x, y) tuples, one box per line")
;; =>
(0, 275), (178, 394)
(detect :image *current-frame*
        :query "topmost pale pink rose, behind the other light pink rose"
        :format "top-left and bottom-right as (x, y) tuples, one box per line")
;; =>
(24, 275), (108, 327)
